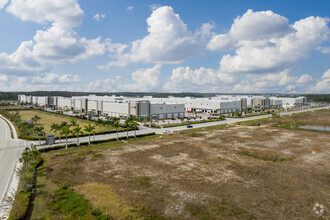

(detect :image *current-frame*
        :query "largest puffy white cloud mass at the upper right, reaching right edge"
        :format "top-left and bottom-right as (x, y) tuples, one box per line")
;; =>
(208, 12), (330, 73)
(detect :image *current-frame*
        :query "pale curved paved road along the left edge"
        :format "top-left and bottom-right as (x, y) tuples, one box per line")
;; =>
(0, 116), (24, 210)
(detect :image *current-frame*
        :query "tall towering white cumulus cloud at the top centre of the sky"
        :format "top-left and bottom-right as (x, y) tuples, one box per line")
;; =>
(103, 6), (203, 69)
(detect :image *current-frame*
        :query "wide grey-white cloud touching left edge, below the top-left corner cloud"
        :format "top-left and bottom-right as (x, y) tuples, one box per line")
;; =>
(0, 23), (106, 75)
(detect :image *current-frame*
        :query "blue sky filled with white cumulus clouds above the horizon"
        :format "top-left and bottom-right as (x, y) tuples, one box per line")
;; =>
(0, 0), (330, 93)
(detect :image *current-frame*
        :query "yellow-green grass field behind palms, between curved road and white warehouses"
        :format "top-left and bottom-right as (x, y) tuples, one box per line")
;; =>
(10, 110), (121, 136)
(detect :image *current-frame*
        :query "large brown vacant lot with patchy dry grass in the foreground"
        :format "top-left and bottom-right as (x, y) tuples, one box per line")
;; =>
(33, 111), (330, 219)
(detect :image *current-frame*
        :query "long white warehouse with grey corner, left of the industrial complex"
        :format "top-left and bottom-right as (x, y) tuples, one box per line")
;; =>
(18, 95), (185, 119)
